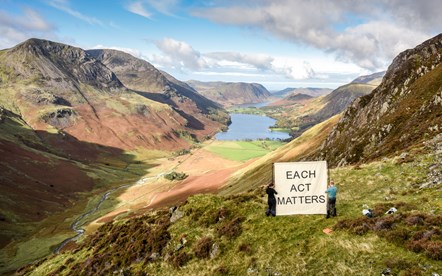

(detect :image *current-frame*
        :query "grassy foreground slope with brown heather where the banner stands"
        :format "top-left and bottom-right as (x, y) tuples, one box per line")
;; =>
(22, 152), (442, 275)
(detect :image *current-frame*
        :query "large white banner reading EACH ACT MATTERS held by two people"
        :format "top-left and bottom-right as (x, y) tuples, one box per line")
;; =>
(273, 161), (327, 216)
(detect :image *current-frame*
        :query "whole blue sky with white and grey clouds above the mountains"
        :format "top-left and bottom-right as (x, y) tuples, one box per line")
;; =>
(0, 0), (442, 91)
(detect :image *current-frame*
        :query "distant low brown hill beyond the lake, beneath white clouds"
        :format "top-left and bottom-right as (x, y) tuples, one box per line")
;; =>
(187, 81), (270, 106)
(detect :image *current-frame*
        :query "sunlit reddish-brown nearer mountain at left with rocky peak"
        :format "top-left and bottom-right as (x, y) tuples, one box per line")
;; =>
(0, 39), (209, 150)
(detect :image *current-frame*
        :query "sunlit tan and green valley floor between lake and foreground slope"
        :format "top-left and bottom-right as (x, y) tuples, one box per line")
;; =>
(86, 140), (274, 233)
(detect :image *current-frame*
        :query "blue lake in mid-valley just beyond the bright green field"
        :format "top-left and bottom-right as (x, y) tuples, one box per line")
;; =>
(215, 113), (290, 140)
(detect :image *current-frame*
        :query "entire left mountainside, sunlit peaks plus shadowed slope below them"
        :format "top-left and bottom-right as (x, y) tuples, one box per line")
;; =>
(0, 39), (229, 260)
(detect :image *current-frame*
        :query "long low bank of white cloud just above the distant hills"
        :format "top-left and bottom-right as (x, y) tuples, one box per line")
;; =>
(147, 38), (365, 84)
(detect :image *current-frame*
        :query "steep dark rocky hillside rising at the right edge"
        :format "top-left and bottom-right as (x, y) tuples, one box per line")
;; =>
(317, 35), (442, 165)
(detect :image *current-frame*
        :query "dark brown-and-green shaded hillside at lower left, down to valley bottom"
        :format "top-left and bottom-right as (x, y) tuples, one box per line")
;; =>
(0, 107), (153, 274)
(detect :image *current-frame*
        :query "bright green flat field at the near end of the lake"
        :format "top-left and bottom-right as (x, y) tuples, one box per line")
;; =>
(206, 140), (284, 161)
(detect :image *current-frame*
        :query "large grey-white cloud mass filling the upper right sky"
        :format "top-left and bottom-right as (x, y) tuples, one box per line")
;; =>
(193, 0), (436, 71)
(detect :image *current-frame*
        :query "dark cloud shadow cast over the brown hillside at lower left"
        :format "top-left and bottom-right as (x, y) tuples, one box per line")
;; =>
(0, 110), (156, 253)
